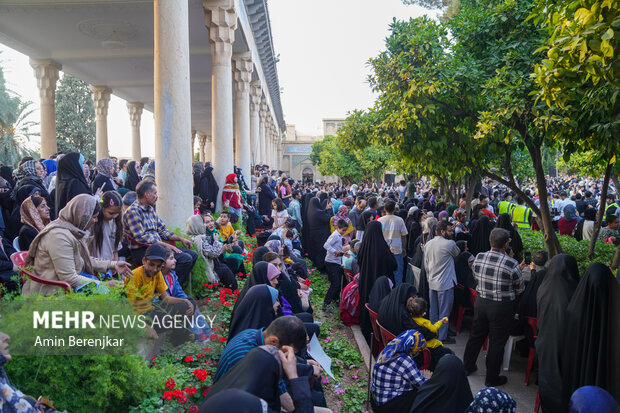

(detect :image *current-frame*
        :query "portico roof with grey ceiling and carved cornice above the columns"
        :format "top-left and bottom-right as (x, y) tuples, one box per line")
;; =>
(0, 0), (284, 135)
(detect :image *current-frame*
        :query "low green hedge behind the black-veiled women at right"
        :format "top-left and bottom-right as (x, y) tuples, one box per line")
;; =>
(519, 229), (616, 274)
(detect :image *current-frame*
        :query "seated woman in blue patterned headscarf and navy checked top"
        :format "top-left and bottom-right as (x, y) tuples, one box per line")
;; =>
(370, 330), (431, 413)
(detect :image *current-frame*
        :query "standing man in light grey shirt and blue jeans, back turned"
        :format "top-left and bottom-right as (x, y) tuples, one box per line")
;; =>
(424, 221), (461, 344)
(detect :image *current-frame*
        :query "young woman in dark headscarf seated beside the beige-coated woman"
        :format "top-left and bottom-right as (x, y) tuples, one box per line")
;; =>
(90, 191), (123, 261)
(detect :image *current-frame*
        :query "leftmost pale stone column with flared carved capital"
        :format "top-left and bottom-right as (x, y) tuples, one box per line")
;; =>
(30, 59), (62, 158)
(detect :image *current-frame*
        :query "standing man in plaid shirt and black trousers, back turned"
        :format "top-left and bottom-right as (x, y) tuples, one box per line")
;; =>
(463, 228), (525, 387)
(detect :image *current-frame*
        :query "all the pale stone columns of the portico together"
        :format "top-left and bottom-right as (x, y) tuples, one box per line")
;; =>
(31, 0), (279, 227)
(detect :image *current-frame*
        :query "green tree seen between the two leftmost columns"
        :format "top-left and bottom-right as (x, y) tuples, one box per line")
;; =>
(56, 74), (96, 161)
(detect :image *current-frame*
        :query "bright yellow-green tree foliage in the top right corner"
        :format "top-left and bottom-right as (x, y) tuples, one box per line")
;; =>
(532, 0), (620, 163)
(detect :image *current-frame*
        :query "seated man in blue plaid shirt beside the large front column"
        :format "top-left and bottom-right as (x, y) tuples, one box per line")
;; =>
(123, 181), (198, 285)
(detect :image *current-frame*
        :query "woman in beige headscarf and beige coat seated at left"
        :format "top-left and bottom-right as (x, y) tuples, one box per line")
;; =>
(22, 194), (131, 296)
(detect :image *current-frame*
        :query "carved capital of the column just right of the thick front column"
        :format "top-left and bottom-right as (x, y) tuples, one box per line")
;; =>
(202, 0), (237, 66)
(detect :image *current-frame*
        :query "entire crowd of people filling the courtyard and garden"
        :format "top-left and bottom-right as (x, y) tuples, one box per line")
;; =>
(0, 152), (620, 413)
